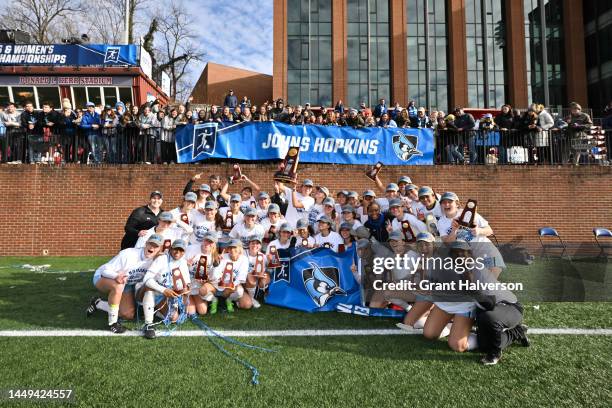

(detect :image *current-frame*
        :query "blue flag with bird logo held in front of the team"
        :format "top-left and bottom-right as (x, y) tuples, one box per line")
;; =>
(266, 246), (361, 312)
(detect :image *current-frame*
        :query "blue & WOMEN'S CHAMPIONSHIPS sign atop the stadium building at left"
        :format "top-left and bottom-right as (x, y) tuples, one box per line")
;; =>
(0, 44), (138, 67)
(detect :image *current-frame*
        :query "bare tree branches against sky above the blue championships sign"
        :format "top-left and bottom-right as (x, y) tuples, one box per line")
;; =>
(1, 0), (81, 44)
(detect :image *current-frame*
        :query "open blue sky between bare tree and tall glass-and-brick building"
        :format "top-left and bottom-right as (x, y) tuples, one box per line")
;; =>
(191, 0), (273, 81)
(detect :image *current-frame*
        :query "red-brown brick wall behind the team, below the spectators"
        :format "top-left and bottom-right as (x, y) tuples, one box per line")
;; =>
(0, 163), (612, 255)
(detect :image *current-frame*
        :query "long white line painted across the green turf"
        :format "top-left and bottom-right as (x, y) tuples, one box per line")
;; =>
(0, 328), (612, 337)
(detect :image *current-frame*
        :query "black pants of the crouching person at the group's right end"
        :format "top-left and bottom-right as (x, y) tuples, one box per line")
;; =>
(476, 303), (523, 353)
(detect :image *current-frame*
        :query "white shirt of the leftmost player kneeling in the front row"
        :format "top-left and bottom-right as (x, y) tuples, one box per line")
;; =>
(94, 248), (155, 285)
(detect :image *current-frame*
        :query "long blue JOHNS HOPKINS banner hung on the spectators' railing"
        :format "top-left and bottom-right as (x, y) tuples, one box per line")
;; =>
(176, 122), (434, 165)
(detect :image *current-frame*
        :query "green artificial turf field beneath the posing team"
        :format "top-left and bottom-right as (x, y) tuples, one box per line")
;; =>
(0, 257), (612, 407)
